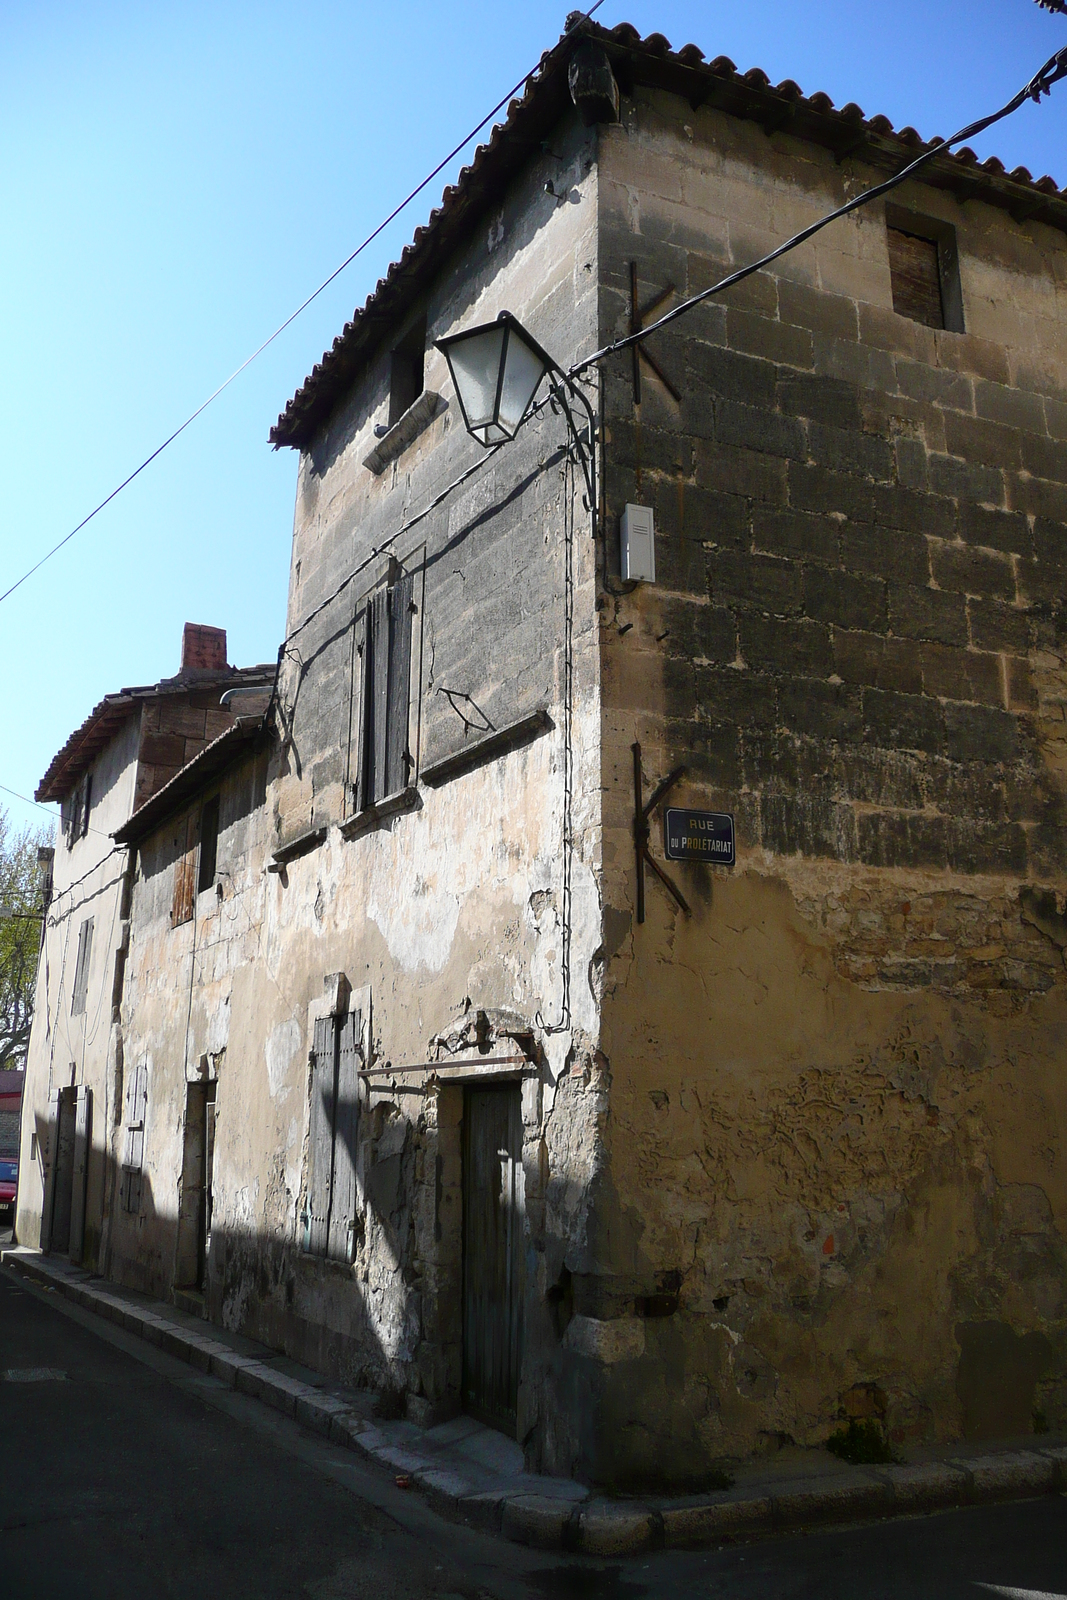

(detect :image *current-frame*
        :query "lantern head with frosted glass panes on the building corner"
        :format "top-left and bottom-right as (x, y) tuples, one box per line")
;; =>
(437, 312), (553, 448)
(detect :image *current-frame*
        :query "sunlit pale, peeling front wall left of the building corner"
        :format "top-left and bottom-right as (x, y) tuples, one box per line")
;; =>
(112, 120), (614, 1458)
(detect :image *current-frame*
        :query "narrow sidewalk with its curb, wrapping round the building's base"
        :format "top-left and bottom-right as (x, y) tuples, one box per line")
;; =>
(0, 1248), (1067, 1555)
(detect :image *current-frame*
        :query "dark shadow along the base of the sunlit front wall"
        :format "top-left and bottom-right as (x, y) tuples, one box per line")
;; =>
(37, 1080), (435, 1421)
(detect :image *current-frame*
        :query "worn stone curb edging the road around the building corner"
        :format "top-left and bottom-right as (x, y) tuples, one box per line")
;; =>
(0, 1250), (1067, 1557)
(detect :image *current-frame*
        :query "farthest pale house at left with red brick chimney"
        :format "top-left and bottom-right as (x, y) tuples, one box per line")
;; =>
(16, 622), (274, 1270)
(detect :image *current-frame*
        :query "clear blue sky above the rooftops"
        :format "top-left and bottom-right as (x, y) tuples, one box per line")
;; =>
(0, 0), (1067, 822)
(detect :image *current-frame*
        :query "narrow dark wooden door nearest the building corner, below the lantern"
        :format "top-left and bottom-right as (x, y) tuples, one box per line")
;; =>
(462, 1085), (525, 1435)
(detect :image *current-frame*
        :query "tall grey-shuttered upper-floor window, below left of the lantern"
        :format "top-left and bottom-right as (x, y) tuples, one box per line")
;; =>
(355, 573), (411, 811)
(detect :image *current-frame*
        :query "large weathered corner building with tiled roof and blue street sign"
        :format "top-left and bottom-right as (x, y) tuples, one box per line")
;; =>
(22, 15), (1067, 1486)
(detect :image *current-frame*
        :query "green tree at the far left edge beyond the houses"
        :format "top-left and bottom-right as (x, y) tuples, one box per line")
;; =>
(0, 806), (50, 1069)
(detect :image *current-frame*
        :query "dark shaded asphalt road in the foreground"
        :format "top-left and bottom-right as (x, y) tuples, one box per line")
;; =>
(0, 1272), (1067, 1600)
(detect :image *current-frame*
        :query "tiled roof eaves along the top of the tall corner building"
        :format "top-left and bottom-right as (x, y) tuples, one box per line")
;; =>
(269, 22), (1067, 450)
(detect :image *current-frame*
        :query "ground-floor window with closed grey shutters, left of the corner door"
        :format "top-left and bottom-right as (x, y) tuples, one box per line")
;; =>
(304, 1011), (362, 1261)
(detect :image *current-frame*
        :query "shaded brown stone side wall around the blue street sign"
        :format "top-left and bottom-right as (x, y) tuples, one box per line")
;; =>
(588, 84), (1067, 1482)
